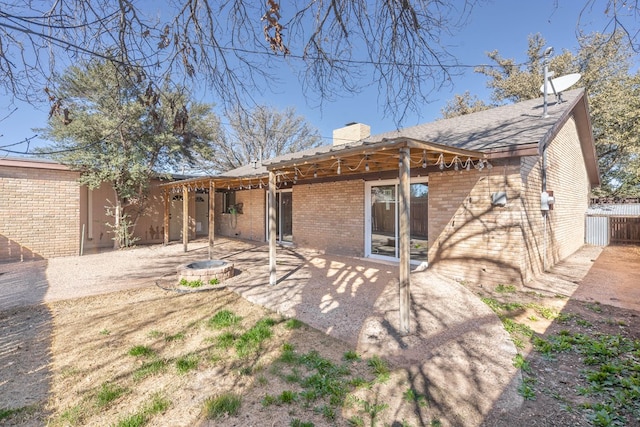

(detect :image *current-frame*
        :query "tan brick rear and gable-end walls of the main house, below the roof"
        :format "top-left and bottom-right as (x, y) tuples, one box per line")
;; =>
(206, 90), (598, 284)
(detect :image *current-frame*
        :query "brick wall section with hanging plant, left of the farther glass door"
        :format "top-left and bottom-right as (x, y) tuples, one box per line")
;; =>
(215, 189), (264, 242)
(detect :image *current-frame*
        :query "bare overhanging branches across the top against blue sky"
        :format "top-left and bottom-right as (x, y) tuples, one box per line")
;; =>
(0, 0), (478, 127)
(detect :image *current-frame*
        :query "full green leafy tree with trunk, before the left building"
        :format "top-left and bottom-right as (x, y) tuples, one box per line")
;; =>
(42, 60), (219, 247)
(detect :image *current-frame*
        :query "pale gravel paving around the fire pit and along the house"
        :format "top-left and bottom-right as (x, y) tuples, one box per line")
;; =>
(0, 239), (624, 425)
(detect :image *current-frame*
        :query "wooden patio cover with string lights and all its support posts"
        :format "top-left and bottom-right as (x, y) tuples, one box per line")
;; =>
(162, 138), (492, 334)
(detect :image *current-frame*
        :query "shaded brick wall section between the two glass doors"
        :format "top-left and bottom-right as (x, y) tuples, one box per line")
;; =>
(292, 180), (365, 256)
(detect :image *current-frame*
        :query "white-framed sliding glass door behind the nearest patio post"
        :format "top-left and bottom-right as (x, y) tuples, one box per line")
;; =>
(365, 178), (429, 262)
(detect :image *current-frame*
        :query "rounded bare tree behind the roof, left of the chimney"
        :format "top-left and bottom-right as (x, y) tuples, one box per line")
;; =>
(208, 105), (322, 172)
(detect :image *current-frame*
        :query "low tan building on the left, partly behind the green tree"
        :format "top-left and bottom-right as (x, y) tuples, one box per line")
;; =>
(0, 158), (195, 263)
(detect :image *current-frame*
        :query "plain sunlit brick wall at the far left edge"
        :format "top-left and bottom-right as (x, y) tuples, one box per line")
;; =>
(0, 165), (80, 262)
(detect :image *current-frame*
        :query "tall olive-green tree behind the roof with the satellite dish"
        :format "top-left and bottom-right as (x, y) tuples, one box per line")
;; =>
(443, 33), (640, 197)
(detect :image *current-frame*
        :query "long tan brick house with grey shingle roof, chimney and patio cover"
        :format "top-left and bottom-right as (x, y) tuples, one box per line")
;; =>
(163, 89), (600, 284)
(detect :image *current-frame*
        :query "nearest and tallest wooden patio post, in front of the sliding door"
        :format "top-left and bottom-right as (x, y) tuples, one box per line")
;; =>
(398, 147), (411, 334)
